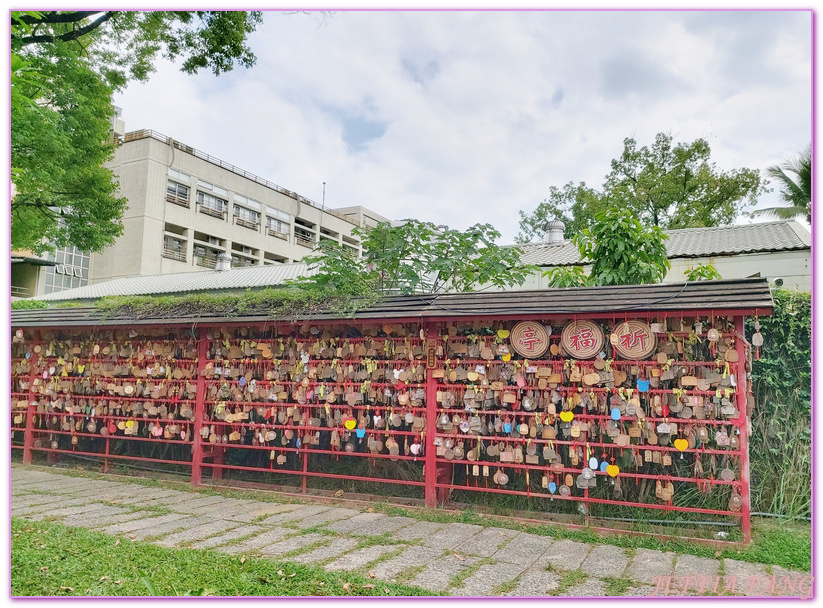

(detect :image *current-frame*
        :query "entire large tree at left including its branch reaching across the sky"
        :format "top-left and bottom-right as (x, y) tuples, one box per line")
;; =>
(11, 11), (260, 253)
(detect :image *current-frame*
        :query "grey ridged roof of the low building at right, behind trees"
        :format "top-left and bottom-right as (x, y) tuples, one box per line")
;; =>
(521, 220), (811, 266)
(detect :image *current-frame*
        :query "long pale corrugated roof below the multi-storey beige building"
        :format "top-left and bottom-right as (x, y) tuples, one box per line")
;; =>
(32, 262), (315, 301)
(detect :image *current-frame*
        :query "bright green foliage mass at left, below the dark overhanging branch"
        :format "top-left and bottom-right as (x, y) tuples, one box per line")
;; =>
(11, 44), (126, 253)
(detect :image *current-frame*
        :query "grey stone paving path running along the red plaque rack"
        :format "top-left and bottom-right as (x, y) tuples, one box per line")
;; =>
(11, 465), (810, 596)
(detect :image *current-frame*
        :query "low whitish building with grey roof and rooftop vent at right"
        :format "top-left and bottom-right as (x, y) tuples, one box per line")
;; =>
(518, 220), (812, 291)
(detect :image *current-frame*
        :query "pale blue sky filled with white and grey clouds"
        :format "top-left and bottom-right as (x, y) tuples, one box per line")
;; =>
(115, 10), (812, 243)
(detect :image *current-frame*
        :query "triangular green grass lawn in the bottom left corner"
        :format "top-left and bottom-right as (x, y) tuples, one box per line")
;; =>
(11, 518), (432, 596)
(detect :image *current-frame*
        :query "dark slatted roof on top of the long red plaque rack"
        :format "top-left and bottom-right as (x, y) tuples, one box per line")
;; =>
(11, 278), (774, 327)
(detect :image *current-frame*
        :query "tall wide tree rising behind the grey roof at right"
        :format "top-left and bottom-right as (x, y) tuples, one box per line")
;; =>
(517, 133), (765, 243)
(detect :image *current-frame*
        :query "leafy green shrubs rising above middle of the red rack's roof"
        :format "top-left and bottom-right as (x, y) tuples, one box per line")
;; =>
(298, 220), (533, 295)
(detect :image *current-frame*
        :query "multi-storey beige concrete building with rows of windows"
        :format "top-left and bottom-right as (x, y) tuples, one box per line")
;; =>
(90, 130), (388, 283)
